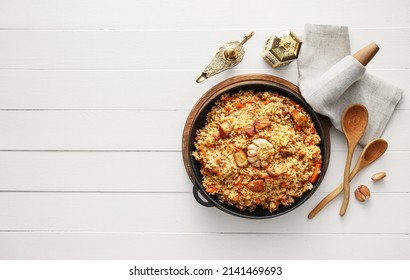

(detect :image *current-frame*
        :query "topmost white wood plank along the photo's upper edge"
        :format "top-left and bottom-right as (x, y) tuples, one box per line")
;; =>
(0, 0), (409, 30)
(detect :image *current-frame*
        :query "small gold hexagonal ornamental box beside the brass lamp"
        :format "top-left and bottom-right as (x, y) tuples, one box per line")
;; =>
(262, 30), (302, 68)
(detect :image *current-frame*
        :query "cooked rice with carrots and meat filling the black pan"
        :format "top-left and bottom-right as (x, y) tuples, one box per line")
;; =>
(193, 90), (322, 212)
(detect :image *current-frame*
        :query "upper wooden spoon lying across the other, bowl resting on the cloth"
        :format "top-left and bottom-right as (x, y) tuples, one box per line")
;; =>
(339, 104), (368, 216)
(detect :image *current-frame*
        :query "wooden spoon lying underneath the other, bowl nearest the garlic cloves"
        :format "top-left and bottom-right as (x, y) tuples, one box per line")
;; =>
(308, 138), (388, 219)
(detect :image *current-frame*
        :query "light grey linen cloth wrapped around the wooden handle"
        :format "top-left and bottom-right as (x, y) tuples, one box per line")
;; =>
(297, 24), (403, 146)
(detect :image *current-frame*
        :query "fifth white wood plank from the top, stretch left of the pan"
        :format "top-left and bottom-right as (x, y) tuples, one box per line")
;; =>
(0, 152), (192, 192)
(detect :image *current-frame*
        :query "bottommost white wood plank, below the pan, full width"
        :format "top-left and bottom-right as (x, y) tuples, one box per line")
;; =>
(0, 232), (410, 260)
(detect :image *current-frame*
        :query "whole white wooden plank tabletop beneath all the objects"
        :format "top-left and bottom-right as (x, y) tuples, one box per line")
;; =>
(0, 0), (410, 259)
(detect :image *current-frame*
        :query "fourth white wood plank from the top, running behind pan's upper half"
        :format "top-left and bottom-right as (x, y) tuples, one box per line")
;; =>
(0, 110), (410, 151)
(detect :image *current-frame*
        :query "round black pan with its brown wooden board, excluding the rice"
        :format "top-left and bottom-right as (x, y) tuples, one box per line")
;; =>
(182, 74), (331, 219)
